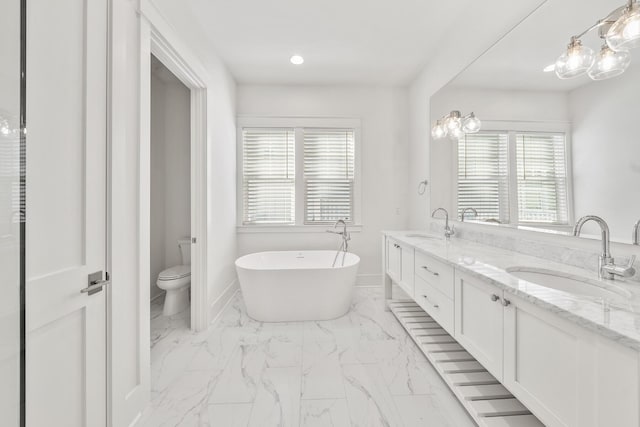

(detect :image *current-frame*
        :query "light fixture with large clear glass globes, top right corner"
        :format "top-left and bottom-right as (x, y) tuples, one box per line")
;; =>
(554, 0), (640, 80)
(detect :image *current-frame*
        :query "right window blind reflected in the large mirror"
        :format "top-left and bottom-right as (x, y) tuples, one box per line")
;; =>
(516, 133), (569, 224)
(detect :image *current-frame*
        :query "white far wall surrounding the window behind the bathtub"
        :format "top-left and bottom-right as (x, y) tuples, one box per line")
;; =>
(238, 86), (409, 285)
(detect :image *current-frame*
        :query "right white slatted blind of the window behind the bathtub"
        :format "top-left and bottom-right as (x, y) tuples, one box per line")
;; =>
(304, 128), (355, 224)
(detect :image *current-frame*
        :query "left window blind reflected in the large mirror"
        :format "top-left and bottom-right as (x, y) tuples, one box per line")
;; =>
(458, 132), (509, 223)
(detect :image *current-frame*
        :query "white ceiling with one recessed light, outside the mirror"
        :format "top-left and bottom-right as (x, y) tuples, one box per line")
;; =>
(154, 0), (471, 85)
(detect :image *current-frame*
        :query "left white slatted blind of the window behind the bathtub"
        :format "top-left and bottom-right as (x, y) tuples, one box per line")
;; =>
(242, 128), (296, 225)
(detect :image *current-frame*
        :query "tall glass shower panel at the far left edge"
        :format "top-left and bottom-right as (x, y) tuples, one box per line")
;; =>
(0, 0), (24, 426)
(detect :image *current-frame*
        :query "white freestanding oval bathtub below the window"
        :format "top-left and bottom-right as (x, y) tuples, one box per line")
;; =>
(236, 251), (360, 322)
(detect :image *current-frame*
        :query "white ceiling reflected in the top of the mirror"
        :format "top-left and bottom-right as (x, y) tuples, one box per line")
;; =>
(451, 0), (640, 91)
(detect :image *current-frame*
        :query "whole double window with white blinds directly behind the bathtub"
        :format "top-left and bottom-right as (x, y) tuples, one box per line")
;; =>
(238, 118), (359, 229)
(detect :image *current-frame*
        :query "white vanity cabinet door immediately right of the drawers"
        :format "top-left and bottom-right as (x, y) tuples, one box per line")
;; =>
(455, 271), (503, 380)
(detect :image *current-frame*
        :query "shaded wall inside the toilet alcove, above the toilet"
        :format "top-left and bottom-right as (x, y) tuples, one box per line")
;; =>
(150, 66), (191, 299)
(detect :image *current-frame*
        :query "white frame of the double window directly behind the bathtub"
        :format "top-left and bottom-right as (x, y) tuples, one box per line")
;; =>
(236, 116), (362, 233)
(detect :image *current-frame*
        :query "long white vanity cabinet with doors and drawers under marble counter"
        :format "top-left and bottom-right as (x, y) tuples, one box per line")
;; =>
(383, 236), (640, 427)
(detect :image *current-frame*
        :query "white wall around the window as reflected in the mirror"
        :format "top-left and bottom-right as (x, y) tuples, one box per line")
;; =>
(429, 86), (570, 215)
